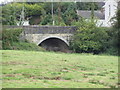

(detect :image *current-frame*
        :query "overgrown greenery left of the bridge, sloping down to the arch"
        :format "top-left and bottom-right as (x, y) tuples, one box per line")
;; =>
(2, 28), (44, 51)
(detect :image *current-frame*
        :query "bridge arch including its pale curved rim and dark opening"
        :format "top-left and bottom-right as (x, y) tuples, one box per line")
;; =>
(38, 36), (69, 52)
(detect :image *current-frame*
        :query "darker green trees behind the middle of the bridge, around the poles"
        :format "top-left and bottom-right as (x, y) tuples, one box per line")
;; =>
(40, 2), (78, 26)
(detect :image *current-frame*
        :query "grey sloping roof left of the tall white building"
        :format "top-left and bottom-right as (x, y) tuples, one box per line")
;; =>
(77, 10), (105, 19)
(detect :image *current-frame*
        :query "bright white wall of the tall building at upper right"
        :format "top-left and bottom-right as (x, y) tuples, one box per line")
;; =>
(97, 0), (118, 27)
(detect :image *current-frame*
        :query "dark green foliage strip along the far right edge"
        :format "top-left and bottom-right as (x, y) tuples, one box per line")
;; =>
(107, 8), (120, 55)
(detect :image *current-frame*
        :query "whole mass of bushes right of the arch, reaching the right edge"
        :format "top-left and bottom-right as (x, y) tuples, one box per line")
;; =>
(70, 5), (120, 55)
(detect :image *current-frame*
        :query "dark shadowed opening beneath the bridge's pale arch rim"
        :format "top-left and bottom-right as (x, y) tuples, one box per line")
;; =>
(39, 38), (69, 52)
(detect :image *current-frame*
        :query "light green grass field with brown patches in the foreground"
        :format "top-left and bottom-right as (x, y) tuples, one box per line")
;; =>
(2, 50), (118, 88)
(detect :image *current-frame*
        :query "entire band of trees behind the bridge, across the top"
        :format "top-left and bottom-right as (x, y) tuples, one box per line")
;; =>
(2, 2), (98, 26)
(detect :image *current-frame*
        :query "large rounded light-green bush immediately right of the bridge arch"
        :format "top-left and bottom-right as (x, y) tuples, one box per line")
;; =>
(71, 18), (108, 54)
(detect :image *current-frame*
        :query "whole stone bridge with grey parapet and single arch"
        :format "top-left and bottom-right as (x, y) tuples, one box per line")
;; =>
(3, 26), (76, 51)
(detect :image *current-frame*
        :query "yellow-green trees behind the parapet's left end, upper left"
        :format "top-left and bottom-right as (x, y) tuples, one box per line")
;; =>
(2, 3), (44, 25)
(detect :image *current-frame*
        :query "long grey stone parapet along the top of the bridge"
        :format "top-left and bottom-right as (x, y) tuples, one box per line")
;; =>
(3, 25), (76, 34)
